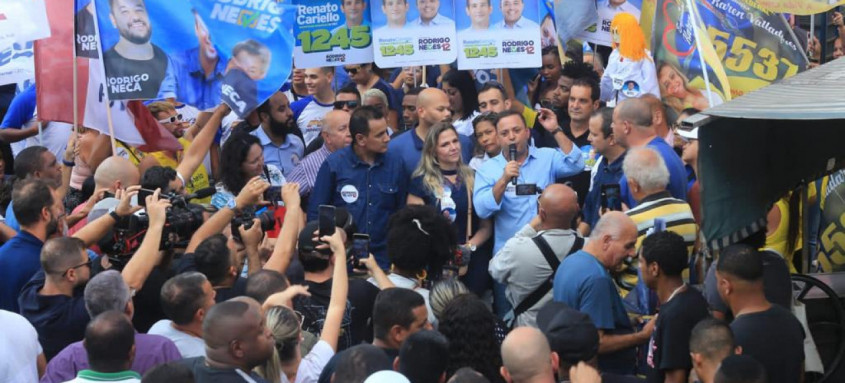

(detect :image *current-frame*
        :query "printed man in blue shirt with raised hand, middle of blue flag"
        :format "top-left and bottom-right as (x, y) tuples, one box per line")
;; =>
(171, 10), (229, 110)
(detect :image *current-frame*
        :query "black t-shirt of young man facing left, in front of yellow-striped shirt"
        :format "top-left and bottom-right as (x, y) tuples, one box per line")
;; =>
(646, 286), (710, 383)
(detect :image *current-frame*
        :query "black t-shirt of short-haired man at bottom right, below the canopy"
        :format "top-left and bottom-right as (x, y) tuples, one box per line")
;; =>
(731, 305), (804, 383)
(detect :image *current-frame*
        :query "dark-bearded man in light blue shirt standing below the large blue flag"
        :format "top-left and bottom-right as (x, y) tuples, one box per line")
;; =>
(252, 92), (305, 176)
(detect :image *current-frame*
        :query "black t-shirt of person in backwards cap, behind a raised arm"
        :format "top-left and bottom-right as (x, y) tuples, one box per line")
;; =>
(293, 279), (379, 351)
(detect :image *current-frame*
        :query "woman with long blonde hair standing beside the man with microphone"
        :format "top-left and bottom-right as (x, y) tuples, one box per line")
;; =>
(407, 123), (493, 296)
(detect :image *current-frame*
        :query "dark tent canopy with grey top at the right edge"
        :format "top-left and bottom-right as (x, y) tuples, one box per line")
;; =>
(698, 60), (845, 250)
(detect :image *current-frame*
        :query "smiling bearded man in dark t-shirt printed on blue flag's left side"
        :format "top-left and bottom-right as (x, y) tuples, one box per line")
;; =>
(103, 0), (176, 100)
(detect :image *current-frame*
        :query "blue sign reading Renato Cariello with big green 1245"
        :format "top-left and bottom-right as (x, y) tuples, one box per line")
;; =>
(293, 0), (373, 68)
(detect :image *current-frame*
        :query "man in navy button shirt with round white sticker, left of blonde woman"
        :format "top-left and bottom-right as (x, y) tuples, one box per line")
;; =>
(308, 106), (408, 269)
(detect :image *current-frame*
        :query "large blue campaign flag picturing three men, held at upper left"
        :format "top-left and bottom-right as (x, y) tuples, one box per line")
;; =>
(95, 0), (295, 117)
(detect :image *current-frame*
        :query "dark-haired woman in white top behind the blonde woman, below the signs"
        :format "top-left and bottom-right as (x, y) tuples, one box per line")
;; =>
(441, 69), (478, 137)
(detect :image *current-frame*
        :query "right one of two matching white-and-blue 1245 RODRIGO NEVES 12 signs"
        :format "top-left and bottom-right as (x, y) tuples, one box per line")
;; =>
(455, 0), (542, 70)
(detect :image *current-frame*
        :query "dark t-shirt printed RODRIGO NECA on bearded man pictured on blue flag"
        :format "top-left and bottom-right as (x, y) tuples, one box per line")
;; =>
(103, 45), (168, 100)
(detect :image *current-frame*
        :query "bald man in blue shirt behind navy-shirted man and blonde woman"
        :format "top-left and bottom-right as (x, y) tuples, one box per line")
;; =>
(388, 88), (472, 181)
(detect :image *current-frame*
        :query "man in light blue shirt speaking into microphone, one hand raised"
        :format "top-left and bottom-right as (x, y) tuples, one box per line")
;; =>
(473, 108), (584, 318)
